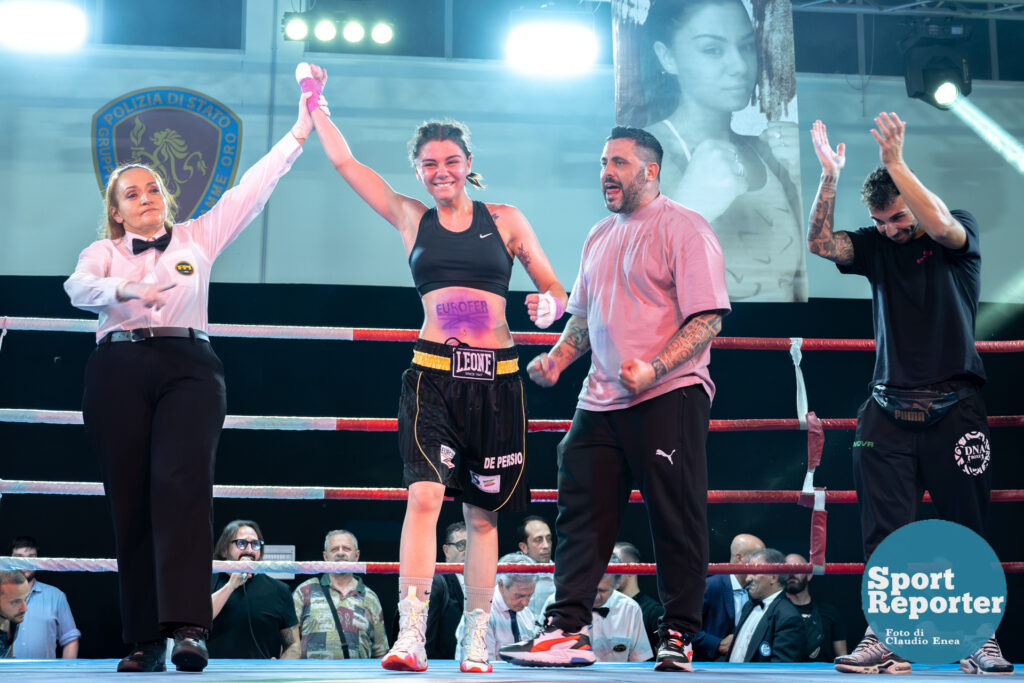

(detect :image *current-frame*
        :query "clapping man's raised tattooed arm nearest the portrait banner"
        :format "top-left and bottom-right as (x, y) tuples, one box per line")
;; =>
(807, 121), (853, 265)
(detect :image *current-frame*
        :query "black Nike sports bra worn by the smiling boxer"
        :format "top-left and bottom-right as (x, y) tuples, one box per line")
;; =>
(409, 202), (512, 296)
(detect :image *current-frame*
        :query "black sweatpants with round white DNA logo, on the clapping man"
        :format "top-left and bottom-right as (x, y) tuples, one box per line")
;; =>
(853, 392), (992, 559)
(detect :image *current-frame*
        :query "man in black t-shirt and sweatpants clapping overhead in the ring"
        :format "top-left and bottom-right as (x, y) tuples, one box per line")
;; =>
(807, 113), (1013, 674)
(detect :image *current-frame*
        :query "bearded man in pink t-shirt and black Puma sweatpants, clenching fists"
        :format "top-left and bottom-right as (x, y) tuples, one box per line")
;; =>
(501, 127), (729, 671)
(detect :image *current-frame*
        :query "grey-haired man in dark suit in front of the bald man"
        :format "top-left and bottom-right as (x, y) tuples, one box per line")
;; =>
(729, 548), (807, 663)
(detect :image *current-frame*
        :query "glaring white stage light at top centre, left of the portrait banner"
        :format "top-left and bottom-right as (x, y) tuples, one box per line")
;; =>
(505, 10), (598, 77)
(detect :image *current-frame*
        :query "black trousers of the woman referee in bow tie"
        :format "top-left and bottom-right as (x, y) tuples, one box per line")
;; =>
(83, 337), (226, 643)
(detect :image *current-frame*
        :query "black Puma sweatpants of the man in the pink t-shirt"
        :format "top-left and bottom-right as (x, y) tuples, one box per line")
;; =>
(547, 385), (711, 634)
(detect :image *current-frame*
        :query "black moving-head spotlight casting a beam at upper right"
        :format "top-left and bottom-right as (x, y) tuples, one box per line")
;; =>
(900, 20), (971, 110)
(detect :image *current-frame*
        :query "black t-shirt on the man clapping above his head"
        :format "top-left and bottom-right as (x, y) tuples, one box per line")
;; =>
(839, 209), (985, 388)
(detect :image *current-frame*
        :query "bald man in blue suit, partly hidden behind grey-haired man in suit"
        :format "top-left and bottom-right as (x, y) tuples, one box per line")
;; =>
(693, 533), (765, 661)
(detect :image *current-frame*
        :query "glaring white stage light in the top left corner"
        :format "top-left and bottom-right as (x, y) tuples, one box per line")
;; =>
(0, 1), (89, 52)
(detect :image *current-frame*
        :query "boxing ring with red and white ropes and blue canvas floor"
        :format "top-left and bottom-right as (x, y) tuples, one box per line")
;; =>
(0, 317), (1024, 682)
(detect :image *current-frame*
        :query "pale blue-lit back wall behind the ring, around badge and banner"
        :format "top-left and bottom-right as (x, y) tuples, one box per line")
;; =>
(0, 3), (1024, 302)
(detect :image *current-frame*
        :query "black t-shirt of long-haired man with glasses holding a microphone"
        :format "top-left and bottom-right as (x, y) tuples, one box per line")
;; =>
(207, 573), (299, 659)
